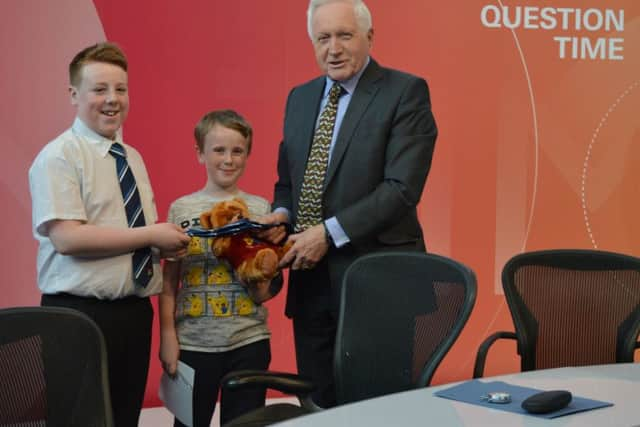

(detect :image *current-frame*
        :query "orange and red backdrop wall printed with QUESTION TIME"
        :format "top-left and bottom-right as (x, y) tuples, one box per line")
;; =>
(0, 0), (640, 405)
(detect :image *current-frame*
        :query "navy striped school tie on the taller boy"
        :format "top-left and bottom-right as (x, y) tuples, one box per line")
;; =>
(109, 142), (153, 287)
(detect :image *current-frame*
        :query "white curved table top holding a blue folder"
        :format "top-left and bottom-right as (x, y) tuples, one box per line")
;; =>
(278, 363), (640, 427)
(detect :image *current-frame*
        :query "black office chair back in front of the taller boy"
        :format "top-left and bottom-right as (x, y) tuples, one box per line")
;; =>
(0, 307), (113, 427)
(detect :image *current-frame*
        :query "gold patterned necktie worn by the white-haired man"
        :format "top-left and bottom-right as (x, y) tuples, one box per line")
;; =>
(295, 82), (342, 233)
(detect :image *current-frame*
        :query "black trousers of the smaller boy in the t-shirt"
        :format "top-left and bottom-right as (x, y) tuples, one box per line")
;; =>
(174, 340), (271, 427)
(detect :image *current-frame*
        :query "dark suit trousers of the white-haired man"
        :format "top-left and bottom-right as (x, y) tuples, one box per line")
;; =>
(287, 261), (338, 408)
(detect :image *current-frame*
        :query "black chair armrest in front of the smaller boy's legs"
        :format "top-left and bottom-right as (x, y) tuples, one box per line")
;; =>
(222, 370), (316, 397)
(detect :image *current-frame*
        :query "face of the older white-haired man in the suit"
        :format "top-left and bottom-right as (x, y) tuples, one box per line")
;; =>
(311, 2), (373, 81)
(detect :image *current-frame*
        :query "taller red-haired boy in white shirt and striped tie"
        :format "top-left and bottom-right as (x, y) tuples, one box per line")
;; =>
(29, 43), (189, 427)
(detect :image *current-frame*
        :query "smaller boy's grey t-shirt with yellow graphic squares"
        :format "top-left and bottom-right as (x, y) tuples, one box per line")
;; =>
(168, 191), (270, 352)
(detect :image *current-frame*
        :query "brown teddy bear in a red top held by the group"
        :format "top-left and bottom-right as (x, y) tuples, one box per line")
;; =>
(200, 197), (289, 285)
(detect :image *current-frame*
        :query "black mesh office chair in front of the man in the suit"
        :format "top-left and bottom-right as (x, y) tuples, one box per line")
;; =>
(223, 252), (476, 426)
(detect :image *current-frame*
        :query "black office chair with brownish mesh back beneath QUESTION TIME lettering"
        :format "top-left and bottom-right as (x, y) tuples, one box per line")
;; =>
(473, 249), (640, 378)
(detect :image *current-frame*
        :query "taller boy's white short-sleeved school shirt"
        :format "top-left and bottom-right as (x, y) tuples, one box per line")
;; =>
(29, 118), (162, 300)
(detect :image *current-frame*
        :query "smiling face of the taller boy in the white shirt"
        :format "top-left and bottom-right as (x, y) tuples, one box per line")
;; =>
(69, 62), (129, 139)
